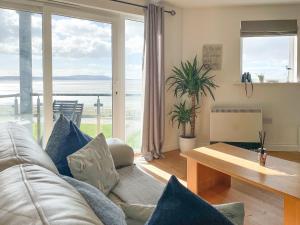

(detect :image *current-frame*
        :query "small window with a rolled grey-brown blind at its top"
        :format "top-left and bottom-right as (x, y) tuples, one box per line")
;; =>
(241, 20), (298, 83)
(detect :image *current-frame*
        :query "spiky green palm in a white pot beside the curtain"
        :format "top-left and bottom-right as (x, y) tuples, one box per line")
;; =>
(167, 56), (218, 151)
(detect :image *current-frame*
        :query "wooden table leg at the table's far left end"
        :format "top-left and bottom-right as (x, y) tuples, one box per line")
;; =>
(187, 158), (231, 194)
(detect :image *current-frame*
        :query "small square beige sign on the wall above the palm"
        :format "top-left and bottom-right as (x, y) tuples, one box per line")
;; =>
(202, 44), (223, 70)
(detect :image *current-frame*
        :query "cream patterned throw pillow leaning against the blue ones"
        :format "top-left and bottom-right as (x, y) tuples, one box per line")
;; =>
(67, 133), (119, 195)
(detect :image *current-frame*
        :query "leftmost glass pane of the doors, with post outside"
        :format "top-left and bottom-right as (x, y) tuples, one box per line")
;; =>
(0, 9), (43, 143)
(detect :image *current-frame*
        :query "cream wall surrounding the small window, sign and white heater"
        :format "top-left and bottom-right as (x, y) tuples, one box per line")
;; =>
(182, 5), (300, 151)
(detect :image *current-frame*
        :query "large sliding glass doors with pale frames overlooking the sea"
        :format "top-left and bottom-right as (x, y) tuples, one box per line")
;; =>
(0, 2), (144, 150)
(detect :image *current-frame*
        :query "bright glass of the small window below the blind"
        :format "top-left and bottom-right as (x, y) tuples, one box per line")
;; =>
(242, 36), (296, 82)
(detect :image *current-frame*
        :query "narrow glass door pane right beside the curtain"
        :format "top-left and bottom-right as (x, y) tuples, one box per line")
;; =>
(125, 20), (144, 150)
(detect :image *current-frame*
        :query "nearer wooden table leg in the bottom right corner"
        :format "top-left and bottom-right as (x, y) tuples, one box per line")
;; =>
(284, 195), (300, 225)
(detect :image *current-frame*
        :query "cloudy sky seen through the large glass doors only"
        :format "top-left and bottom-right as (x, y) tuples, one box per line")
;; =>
(0, 9), (144, 79)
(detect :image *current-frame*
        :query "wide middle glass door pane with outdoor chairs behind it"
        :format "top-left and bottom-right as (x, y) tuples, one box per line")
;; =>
(52, 15), (112, 137)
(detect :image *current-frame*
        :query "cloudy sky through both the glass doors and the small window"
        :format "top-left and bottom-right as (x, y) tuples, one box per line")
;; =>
(0, 9), (291, 81)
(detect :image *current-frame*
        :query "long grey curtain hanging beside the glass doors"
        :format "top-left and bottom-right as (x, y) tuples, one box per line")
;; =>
(142, 4), (165, 161)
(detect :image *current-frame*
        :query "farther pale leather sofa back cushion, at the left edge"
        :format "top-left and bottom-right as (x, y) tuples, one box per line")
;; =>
(0, 122), (58, 173)
